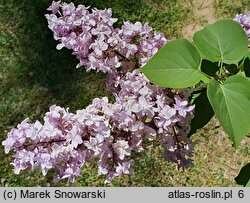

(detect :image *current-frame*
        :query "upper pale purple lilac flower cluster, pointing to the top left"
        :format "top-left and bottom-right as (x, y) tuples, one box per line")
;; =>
(46, 1), (167, 73)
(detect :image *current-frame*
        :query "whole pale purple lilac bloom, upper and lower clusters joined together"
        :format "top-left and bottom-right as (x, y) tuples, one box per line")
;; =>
(2, 1), (194, 182)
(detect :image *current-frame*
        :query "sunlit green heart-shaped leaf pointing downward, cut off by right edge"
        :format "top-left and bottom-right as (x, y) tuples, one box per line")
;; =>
(207, 75), (250, 147)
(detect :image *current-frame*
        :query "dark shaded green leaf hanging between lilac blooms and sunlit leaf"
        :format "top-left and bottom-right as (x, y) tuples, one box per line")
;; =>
(188, 91), (214, 137)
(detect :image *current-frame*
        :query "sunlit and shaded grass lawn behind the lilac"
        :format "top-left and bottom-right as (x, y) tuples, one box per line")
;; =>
(0, 0), (250, 186)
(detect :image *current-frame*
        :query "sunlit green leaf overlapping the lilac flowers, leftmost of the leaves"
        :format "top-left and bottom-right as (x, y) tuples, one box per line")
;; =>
(141, 39), (209, 88)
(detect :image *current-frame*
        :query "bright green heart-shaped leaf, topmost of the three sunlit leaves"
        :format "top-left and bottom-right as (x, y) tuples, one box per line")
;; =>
(193, 20), (248, 64)
